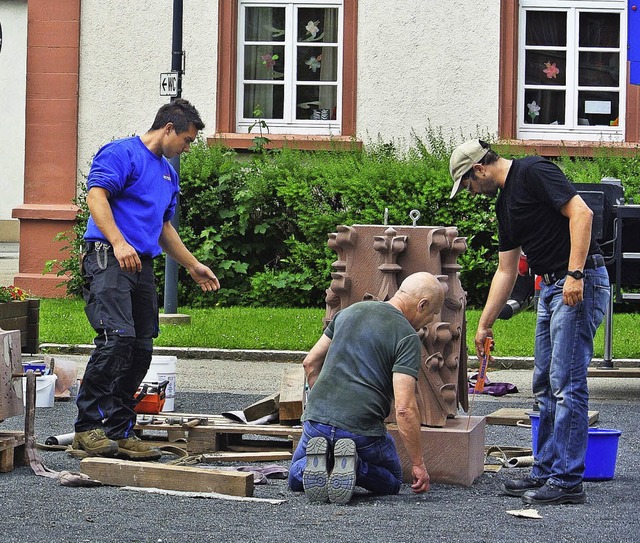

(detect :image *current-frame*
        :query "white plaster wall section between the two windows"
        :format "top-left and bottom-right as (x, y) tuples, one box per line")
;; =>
(357, 0), (500, 147)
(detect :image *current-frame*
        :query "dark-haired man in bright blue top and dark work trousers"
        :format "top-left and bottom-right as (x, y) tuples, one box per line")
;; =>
(70, 99), (220, 460)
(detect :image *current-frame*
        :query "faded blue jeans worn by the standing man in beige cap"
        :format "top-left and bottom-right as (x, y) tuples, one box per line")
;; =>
(531, 267), (610, 488)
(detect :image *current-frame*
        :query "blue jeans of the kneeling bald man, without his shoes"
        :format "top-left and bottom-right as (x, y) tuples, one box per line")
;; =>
(289, 421), (402, 495)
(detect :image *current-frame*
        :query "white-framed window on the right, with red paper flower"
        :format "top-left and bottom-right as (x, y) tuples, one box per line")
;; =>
(517, 0), (627, 141)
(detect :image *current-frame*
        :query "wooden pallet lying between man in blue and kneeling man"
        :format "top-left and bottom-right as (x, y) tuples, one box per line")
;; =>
(134, 413), (302, 456)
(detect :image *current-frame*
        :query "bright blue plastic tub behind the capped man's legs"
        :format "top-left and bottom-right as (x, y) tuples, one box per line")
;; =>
(528, 413), (622, 481)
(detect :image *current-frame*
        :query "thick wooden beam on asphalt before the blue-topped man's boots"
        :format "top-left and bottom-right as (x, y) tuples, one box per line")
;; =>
(80, 457), (253, 496)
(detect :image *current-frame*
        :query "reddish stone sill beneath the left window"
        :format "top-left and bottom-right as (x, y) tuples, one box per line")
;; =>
(207, 132), (362, 151)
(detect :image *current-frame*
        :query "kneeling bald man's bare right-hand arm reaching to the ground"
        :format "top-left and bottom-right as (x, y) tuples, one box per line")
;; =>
(393, 373), (430, 493)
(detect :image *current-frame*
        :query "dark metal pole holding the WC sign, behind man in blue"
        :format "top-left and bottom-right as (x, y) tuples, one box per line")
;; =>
(164, 0), (183, 315)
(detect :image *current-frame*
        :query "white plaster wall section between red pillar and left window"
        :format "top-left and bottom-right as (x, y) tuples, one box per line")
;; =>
(78, 0), (218, 182)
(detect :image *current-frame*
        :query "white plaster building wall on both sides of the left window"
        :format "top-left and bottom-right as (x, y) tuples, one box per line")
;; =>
(78, 0), (500, 174)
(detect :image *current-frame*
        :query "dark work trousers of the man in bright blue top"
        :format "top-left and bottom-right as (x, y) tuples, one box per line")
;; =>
(75, 245), (159, 439)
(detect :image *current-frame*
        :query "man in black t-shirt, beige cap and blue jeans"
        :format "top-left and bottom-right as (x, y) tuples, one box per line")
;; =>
(449, 139), (609, 504)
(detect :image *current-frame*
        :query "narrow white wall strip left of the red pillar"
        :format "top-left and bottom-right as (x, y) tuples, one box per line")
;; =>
(0, 0), (27, 241)
